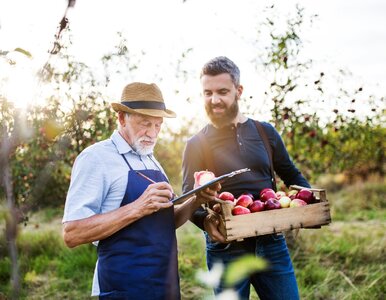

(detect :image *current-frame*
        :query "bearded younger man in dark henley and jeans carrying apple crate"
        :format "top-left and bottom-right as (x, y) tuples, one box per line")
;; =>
(183, 57), (309, 300)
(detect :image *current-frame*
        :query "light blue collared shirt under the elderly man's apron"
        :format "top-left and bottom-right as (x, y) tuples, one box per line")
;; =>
(62, 131), (166, 296)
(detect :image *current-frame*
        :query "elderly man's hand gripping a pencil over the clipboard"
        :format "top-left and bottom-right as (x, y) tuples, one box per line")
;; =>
(135, 182), (173, 215)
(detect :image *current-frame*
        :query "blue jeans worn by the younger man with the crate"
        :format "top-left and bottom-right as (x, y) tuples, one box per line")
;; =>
(205, 233), (299, 300)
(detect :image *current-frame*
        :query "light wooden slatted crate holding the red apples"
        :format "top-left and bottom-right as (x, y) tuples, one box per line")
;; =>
(220, 186), (331, 242)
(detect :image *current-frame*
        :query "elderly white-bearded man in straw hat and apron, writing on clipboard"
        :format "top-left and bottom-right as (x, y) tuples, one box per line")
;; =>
(63, 82), (220, 300)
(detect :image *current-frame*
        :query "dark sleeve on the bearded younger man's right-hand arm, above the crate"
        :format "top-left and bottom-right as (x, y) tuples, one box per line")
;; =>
(264, 123), (310, 187)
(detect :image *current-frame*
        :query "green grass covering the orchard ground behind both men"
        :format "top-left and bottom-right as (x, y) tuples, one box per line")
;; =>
(0, 180), (386, 300)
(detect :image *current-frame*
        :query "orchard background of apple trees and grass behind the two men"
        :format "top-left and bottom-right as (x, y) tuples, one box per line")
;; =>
(0, 2), (386, 299)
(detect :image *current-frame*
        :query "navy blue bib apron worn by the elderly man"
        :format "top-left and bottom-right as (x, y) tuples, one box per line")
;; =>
(98, 155), (180, 300)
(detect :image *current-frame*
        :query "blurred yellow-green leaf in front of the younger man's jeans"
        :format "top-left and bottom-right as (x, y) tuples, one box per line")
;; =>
(224, 255), (268, 287)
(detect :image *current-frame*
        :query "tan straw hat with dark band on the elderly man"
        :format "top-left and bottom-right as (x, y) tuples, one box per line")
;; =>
(111, 82), (176, 118)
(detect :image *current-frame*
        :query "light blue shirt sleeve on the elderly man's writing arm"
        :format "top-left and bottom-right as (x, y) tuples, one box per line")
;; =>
(63, 151), (106, 222)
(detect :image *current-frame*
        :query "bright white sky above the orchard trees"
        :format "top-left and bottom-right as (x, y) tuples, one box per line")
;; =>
(0, 0), (386, 123)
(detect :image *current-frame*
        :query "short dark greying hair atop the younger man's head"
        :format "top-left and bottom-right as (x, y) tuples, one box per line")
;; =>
(200, 56), (240, 86)
